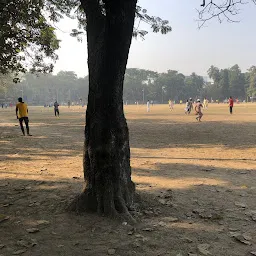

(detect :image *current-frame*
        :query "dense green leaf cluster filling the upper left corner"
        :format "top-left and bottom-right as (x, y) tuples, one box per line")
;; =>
(0, 0), (62, 74)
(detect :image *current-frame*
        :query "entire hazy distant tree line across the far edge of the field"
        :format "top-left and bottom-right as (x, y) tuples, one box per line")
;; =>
(0, 65), (256, 105)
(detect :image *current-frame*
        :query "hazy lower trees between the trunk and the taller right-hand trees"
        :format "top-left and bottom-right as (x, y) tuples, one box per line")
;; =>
(124, 69), (204, 103)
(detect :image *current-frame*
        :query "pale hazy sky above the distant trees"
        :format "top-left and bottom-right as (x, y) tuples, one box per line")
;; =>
(55, 0), (256, 76)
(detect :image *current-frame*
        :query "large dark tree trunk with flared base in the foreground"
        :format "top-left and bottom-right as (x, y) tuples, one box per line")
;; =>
(71, 0), (137, 220)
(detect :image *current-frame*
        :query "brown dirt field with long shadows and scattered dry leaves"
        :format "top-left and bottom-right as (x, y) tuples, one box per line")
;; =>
(0, 104), (256, 256)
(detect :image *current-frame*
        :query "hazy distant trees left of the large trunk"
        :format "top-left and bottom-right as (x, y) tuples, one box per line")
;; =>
(0, 71), (89, 105)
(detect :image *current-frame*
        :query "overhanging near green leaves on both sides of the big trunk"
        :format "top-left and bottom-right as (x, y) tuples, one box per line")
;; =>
(0, 0), (171, 74)
